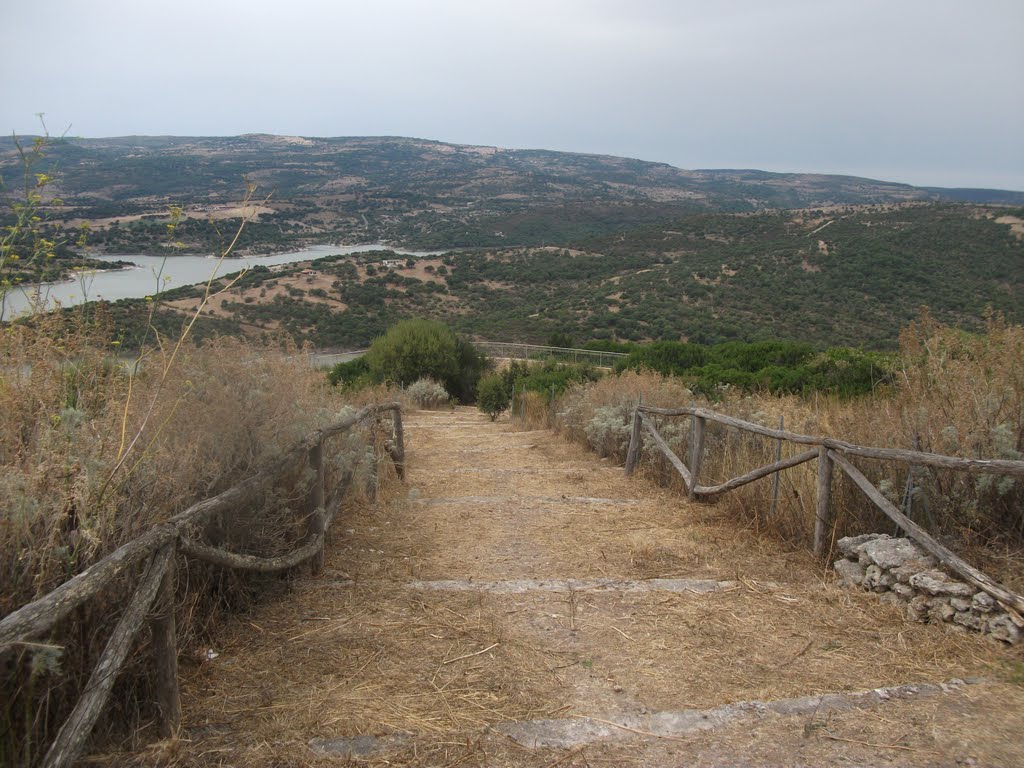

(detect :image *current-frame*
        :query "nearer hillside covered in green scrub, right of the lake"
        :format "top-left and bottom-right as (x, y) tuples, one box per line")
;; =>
(72, 205), (1024, 351)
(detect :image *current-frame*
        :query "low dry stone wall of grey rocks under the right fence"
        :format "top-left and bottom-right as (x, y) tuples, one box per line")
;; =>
(833, 534), (1022, 644)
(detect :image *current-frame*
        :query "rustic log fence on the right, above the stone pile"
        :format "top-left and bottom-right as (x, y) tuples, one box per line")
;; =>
(626, 406), (1024, 613)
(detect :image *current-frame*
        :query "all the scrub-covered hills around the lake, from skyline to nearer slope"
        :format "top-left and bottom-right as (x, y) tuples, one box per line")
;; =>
(6, 135), (1024, 348)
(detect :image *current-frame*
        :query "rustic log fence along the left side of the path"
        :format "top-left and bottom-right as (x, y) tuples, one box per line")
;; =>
(0, 402), (406, 768)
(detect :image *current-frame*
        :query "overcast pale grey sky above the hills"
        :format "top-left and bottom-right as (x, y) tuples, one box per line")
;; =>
(0, 0), (1024, 189)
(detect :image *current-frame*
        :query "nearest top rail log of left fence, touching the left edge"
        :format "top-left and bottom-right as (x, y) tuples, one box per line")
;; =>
(0, 525), (177, 646)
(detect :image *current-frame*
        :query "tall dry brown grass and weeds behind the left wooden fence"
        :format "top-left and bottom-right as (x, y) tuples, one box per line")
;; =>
(0, 314), (391, 764)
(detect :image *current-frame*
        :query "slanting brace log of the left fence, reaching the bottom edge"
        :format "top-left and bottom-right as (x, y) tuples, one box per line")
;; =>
(42, 543), (174, 768)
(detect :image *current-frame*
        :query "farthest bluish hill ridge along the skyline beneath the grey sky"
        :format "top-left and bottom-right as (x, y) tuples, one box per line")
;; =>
(0, 134), (1024, 217)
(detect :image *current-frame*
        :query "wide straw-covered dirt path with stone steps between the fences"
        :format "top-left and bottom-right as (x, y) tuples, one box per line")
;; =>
(157, 409), (1024, 766)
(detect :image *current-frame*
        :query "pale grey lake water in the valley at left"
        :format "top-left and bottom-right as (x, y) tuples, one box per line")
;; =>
(2, 244), (443, 319)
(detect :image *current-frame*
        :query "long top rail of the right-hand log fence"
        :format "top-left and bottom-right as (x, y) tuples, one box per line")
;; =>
(641, 406), (1024, 477)
